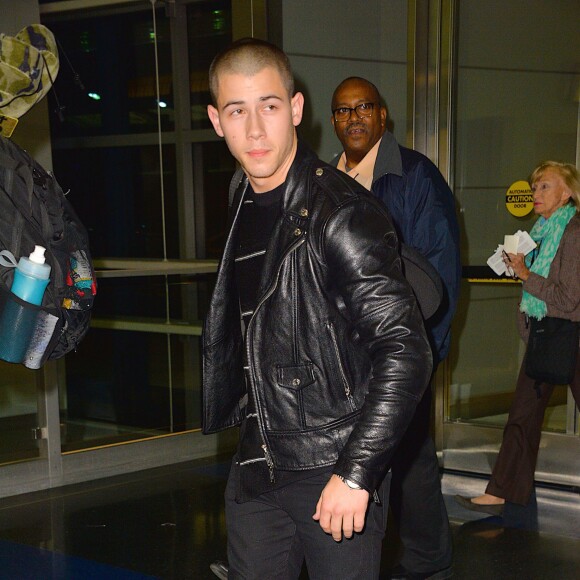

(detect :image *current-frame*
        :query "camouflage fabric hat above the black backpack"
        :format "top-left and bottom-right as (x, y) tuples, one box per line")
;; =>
(0, 24), (59, 119)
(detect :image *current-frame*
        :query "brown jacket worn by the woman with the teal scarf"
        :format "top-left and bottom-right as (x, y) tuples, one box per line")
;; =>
(523, 218), (580, 320)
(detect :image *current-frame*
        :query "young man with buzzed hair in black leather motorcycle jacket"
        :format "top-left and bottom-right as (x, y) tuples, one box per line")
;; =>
(203, 39), (432, 580)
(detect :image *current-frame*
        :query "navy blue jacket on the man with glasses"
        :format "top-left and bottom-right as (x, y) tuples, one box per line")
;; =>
(331, 132), (461, 363)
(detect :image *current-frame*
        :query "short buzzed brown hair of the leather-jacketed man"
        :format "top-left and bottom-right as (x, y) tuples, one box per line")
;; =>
(209, 38), (294, 106)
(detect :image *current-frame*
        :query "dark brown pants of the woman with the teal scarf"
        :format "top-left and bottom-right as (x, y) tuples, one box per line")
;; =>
(485, 352), (580, 505)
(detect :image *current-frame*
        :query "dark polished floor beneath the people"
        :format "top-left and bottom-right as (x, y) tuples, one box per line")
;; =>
(0, 461), (580, 580)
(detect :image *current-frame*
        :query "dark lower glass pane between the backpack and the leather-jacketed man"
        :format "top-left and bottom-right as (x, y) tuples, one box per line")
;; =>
(61, 329), (200, 452)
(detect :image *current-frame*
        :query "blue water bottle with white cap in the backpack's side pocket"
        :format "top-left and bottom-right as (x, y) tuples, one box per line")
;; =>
(0, 246), (50, 363)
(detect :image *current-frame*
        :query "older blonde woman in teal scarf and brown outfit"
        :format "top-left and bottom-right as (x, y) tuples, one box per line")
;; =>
(456, 161), (580, 515)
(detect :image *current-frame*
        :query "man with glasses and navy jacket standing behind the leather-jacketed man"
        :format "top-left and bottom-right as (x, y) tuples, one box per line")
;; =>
(331, 77), (461, 580)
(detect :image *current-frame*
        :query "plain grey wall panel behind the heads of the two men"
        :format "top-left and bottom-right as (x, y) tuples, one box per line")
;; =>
(281, 0), (407, 161)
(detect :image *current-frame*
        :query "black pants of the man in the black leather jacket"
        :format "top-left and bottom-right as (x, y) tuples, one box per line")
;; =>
(225, 471), (390, 580)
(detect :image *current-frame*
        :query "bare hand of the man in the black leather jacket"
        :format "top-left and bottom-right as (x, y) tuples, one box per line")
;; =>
(312, 475), (369, 542)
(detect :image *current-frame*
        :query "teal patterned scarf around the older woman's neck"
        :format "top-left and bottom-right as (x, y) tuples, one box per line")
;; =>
(520, 203), (576, 320)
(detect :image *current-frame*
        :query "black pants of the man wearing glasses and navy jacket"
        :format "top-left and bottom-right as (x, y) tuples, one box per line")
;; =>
(390, 388), (452, 572)
